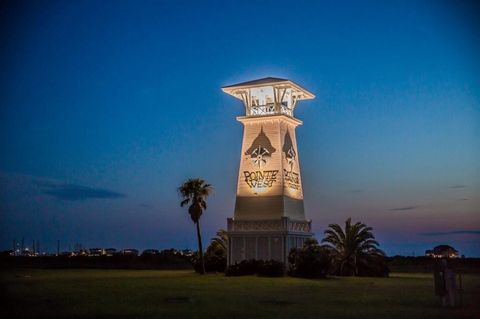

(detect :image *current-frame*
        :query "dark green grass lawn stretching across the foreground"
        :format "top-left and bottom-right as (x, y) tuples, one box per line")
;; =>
(1, 269), (480, 319)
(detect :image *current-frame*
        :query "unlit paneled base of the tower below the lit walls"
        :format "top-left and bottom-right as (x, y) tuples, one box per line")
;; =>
(227, 217), (313, 266)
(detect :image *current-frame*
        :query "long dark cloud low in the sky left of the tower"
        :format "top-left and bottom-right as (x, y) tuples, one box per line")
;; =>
(35, 182), (126, 201)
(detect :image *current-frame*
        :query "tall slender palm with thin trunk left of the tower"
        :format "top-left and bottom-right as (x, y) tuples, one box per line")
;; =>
(178, 178), (213, 274)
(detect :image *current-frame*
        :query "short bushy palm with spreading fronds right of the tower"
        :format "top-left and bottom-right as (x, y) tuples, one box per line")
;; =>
(322, 218), (385, 276)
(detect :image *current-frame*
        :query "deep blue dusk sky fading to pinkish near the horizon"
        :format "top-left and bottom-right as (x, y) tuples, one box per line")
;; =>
(0, 1), (480, 256)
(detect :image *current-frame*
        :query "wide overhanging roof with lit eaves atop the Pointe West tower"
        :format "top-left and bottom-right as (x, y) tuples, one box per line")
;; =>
(222, 77), (315, 100)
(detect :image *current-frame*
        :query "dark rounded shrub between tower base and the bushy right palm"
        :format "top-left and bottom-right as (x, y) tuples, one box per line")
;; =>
(288, 239), (331, 278)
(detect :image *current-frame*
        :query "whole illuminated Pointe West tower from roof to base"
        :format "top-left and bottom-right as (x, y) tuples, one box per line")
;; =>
(222, 78), (315, 265)
